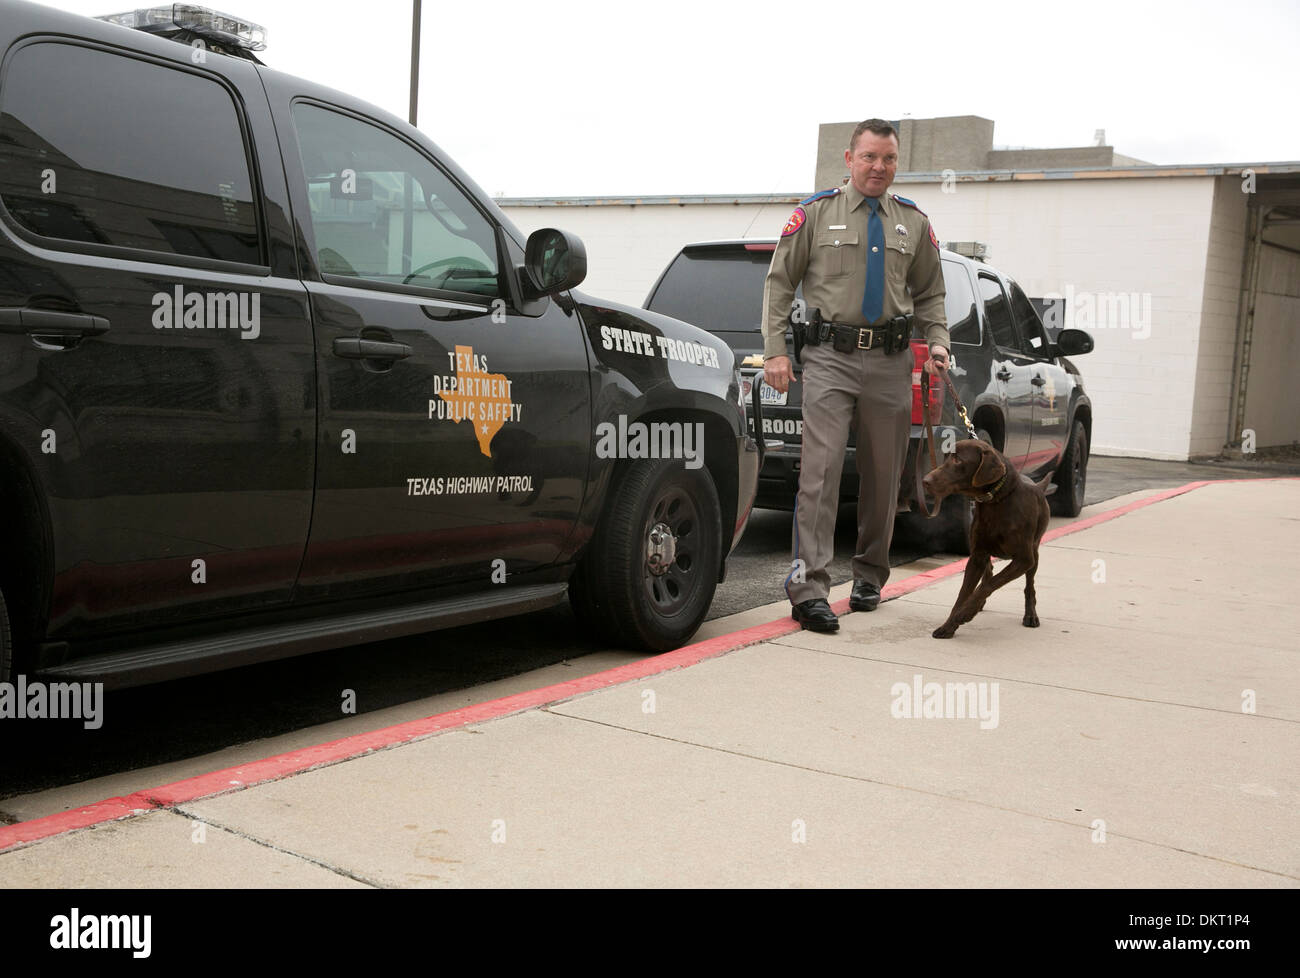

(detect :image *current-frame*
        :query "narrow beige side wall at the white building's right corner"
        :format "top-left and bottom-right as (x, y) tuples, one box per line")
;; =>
(1188, 177), (1247, 455)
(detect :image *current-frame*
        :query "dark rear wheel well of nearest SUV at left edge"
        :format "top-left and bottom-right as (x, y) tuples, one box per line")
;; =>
(0, 440), (51, 667)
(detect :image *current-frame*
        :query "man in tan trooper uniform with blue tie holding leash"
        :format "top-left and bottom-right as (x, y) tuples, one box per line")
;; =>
(763, 118), (949, 632)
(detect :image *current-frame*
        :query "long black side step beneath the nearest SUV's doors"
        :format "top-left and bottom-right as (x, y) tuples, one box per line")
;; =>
(39, 583), (568, 689)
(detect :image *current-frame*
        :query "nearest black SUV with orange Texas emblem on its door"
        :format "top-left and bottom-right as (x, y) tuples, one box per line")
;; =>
(0, 0), (759, 685)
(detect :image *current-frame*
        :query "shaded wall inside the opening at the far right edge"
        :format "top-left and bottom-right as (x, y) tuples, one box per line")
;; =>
(1243, 245), (1300, 449)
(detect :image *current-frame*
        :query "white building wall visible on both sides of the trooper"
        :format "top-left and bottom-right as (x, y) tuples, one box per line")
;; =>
(503, 177), (1227, 459)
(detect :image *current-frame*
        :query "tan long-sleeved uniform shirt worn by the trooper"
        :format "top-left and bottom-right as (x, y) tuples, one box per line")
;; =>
(763, 183), (952, 356)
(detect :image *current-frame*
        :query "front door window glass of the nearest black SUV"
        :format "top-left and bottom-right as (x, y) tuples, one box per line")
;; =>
(294, 103), (501, 295)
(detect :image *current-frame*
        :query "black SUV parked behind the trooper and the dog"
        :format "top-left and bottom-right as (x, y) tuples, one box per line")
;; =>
(645, 238), (1092, 554)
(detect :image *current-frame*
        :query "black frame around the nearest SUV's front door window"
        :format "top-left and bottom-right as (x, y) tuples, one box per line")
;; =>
(281, 95), (504, 310)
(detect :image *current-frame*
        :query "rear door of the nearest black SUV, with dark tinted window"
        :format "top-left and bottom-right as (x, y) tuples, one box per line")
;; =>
(0, 36), (316, 640)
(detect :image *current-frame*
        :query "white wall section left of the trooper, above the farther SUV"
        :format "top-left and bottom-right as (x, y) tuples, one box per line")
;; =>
(502, 195), (801, 306)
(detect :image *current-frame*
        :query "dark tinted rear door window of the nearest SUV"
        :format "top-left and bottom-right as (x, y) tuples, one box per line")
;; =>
(0, 43), (261, 264)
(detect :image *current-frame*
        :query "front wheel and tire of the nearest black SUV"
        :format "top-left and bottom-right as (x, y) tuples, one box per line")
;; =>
(569, 459), (722, 652)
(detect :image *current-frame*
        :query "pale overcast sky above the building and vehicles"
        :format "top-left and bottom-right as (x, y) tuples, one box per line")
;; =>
(40, 0), (1300, 196)
